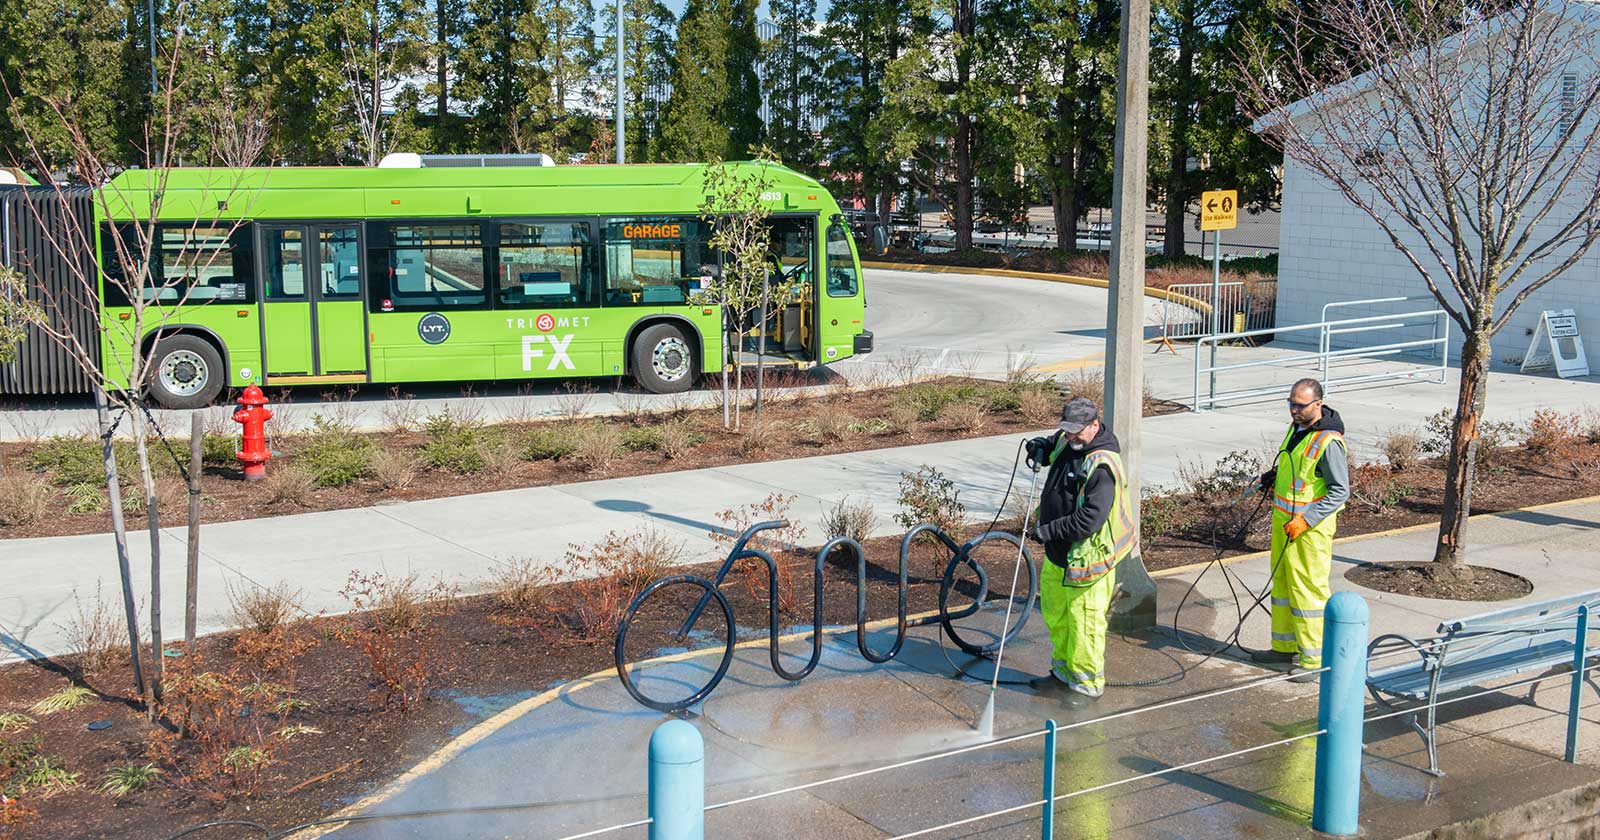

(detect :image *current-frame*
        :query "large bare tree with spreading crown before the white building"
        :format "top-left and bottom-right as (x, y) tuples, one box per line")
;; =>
(1240, 0), (1600, 579)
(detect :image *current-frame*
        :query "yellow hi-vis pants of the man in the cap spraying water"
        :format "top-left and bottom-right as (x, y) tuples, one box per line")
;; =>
(1038, 560), (1117, 698)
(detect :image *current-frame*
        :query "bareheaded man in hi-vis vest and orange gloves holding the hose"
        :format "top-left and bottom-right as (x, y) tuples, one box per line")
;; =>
(1251, 379), (1350, 683)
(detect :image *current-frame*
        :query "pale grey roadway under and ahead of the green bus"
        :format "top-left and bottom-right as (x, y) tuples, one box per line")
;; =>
(0, 269), (1158, 440)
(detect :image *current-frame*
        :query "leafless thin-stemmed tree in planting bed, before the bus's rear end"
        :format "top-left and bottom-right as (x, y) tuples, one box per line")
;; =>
(6, 3), (259, 715)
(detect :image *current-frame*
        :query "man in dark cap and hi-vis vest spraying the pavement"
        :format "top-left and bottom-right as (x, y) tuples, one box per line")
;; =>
(1027, 397), (1139, 698)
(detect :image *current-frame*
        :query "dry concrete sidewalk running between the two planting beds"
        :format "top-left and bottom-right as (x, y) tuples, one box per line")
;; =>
(0, 355), (1600, 661)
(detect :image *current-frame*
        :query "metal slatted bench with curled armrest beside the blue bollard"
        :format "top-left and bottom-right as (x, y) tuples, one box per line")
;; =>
(1366, 589), (1600, 776)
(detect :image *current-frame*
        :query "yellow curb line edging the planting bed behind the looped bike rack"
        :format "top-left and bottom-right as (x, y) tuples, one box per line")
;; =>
(288, 610), (939, 840)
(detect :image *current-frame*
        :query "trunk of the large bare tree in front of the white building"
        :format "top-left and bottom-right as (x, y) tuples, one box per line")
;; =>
(1434, 326), (1490, 581)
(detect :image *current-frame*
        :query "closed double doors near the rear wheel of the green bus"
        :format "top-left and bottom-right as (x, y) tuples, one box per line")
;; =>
(256, 224), (368, 384)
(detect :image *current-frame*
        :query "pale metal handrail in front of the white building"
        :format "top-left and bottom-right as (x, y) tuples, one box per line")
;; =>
(1190, 307), (1450, 411)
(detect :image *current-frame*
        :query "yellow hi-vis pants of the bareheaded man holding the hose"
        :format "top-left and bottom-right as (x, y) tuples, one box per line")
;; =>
(1272, 510), (1338, 669)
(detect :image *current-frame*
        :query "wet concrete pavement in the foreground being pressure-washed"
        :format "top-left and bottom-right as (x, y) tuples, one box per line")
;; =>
(301, 502), (1600, 840)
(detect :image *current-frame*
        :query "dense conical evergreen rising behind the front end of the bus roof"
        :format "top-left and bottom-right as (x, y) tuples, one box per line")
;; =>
(658, 0), (730, 162)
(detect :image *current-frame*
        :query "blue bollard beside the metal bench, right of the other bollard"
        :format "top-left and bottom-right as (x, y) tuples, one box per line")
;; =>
(1310, 592), (1366, 835)
